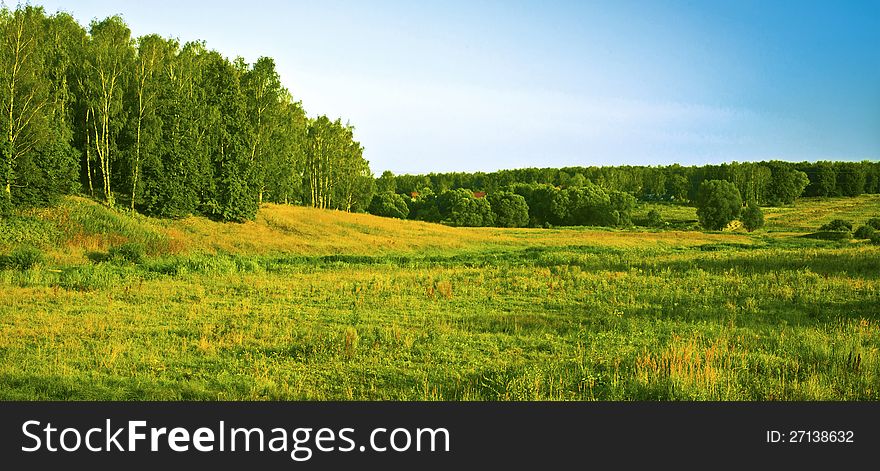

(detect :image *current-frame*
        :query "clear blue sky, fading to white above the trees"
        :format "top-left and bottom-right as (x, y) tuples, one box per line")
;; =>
(29, 0), (880, 175)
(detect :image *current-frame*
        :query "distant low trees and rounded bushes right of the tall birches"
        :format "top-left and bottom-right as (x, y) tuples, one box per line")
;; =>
(369, 161), (880, 227)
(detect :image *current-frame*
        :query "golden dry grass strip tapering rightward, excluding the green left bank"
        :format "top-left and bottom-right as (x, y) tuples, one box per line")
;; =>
(156, 204), (749, 255)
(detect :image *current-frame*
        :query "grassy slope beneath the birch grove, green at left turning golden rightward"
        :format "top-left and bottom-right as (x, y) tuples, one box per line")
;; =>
(0, 197), (784, 264)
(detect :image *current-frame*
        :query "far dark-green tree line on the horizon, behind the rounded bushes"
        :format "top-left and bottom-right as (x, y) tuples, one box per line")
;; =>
(377, 161), (880, 206)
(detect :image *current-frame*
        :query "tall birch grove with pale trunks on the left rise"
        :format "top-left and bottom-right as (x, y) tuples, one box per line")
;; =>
(0, 5), (374, 221)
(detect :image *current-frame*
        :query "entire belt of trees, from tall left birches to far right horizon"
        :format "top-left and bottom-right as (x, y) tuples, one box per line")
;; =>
(0, 6), (880, 227)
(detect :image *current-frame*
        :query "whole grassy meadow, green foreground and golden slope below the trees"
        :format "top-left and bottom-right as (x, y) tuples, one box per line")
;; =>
(0, 195), (880, 400)
